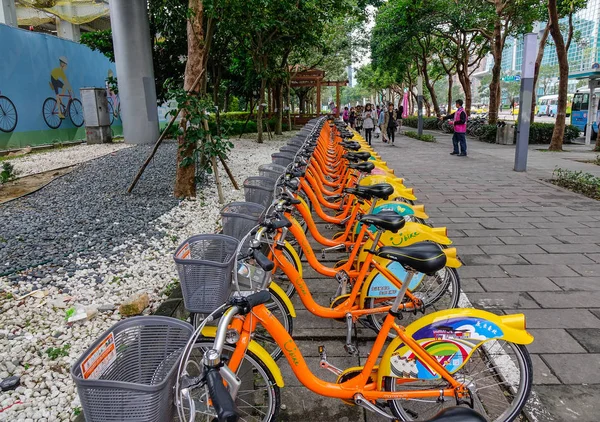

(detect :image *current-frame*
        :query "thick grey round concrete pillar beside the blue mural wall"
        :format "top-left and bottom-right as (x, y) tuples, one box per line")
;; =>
(110, 0), (158, 144)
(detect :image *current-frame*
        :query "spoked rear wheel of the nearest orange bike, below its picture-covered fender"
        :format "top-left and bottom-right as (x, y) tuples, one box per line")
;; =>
(385, 339), (533, 422)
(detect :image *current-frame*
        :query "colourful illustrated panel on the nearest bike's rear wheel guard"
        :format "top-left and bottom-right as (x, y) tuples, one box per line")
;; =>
(388, 317), (503, 379)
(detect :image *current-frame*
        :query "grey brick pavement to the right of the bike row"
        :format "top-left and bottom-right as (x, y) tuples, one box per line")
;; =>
(374, 132), (600, 422)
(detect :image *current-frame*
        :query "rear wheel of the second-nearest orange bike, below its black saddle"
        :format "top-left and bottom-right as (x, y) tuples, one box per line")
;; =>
(364, 267), (460, 332)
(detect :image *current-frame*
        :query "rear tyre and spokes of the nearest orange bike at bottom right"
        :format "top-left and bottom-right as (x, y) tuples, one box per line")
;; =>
(384, 339), (533, 422)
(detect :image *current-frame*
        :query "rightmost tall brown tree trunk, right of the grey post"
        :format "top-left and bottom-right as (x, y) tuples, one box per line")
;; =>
(548, 0), (569, 151)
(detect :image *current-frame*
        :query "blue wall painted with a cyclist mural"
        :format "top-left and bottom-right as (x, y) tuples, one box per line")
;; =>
(0, 24), (122, 151)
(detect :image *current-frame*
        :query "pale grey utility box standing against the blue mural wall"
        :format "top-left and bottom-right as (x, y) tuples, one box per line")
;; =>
(79, 88), (112, 144)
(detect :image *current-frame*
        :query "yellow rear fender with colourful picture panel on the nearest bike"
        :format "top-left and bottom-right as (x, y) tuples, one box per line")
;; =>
(377, 309), (533, 385)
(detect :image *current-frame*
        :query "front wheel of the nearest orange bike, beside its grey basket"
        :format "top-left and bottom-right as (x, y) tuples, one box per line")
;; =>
(186, 339), (281, 422)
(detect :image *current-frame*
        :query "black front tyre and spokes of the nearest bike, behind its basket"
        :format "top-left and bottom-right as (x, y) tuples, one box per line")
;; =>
(186, 338), (281, 422)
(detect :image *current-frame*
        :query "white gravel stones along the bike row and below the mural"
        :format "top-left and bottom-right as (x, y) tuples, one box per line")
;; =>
(0, 133), (293, 422)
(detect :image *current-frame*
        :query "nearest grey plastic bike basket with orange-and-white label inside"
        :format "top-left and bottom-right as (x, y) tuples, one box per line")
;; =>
(71, 316), (194, 422)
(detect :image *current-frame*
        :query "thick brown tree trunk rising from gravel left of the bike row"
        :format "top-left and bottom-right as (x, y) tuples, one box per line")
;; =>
(174, 0), (205, 198)
